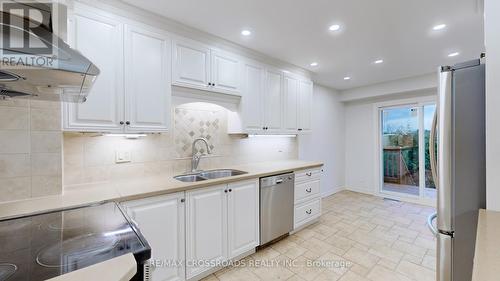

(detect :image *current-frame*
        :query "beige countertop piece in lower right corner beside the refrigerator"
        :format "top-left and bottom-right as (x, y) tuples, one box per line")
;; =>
(472, 210), (500, 281)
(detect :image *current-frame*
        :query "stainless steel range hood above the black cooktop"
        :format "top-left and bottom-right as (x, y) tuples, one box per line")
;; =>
(0, 4), (99, 103)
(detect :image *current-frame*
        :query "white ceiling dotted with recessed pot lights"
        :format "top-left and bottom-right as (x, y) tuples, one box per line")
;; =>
(124, 0), (484, 89)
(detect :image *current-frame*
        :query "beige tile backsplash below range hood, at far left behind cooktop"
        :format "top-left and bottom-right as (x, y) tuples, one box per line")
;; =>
(0, 99), (62, 202)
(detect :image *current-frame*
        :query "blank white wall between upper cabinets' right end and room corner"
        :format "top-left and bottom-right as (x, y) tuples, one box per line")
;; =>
(299, 84), (345, 196)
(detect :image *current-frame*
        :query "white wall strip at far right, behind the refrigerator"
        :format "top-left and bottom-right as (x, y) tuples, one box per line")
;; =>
(484, 0), (500, 211)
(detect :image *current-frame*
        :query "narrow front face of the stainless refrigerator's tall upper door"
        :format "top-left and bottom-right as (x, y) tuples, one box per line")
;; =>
(437, 68), (454, 232)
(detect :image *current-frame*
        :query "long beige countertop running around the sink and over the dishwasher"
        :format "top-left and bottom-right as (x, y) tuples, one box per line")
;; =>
(0, 160), (323, 219)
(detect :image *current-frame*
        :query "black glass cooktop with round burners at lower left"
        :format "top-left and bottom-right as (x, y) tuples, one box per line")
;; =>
(0, 202), (151, 281)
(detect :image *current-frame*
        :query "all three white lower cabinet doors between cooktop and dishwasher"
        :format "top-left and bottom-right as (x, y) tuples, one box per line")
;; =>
(121, 179), (259, 281)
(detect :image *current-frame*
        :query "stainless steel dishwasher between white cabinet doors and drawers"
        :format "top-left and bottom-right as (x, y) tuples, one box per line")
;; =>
(260, 173), (295, 245)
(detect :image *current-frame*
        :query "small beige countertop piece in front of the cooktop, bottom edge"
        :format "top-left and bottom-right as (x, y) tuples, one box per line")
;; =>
(49, 253), (137, 281)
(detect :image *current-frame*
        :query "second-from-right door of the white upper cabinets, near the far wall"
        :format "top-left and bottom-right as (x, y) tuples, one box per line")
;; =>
(283, 76), (299, 132)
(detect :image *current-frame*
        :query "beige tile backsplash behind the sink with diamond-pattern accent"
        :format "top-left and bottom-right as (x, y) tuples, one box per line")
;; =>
(64, 103), (298, 188)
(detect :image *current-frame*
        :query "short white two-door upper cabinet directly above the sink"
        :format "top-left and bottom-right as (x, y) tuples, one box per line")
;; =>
(173, 39), (242, 95)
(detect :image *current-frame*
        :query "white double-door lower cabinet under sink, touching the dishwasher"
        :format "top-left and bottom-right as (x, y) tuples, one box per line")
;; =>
(186, 179), (259, 279)
